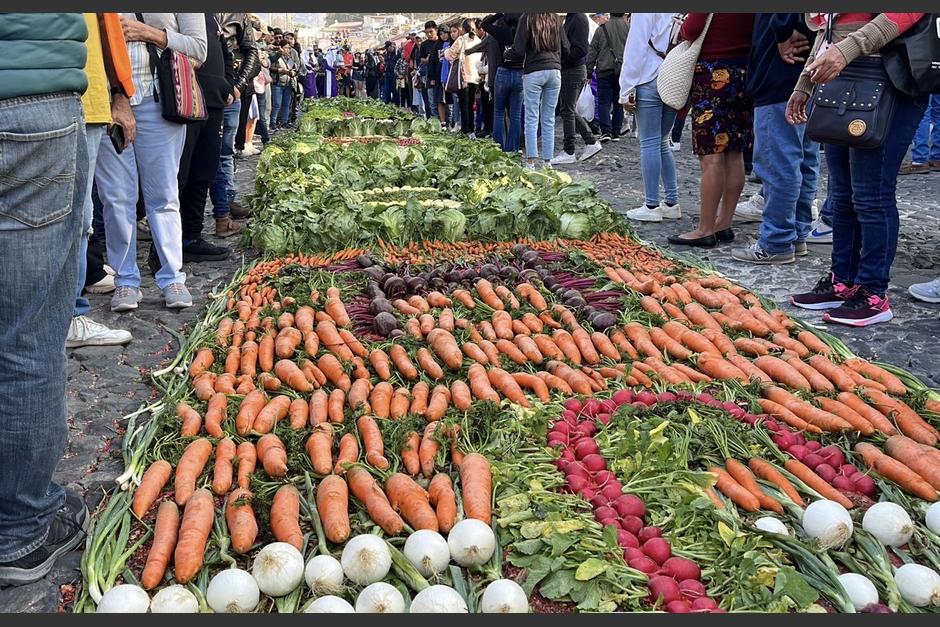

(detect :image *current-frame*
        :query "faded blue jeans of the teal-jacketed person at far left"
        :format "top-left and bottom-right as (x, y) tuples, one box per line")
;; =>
(0, 93), (88, 562)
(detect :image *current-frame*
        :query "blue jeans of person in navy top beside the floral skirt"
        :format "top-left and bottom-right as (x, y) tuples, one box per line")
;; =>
(754, 102), (819, 254)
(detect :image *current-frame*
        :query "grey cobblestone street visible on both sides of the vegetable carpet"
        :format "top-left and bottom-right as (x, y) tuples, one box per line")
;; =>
(0, 125), (940, 612)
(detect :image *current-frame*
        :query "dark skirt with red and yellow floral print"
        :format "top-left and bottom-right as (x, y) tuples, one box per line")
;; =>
(689, 59), (754, 156)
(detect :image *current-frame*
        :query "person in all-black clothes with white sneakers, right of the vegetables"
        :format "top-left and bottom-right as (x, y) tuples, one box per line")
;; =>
(552, 13), (601, 166)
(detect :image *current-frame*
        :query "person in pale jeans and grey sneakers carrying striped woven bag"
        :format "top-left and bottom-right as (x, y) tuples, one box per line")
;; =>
(95, 13), (206, 312)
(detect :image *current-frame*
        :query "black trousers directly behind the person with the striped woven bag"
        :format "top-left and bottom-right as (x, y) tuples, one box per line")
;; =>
(179, 109), (224, 245)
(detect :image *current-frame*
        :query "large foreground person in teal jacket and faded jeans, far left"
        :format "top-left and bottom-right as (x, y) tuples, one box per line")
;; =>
(0, 13), (91, 586)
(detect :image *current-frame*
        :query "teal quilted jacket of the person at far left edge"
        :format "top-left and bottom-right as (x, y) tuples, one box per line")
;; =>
(0, 13), (88, 100)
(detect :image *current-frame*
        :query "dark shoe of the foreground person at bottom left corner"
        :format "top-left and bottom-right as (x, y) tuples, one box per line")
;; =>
(0, 491), (89, 586)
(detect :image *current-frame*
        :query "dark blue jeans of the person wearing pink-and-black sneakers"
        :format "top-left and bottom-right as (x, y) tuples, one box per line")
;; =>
(826, 94), (927, 295)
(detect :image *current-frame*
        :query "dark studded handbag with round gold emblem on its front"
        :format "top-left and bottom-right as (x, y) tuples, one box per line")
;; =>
(806, 17), (897, 148)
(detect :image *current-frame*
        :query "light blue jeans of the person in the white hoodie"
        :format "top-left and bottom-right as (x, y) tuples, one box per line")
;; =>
(636, 80), (679, 207)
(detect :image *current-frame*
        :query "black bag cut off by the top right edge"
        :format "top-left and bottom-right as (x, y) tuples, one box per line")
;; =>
(881, 13), (940, 96)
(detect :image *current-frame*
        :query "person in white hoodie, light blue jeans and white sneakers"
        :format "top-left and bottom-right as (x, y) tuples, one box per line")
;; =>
(620, 13), (682, 222)
